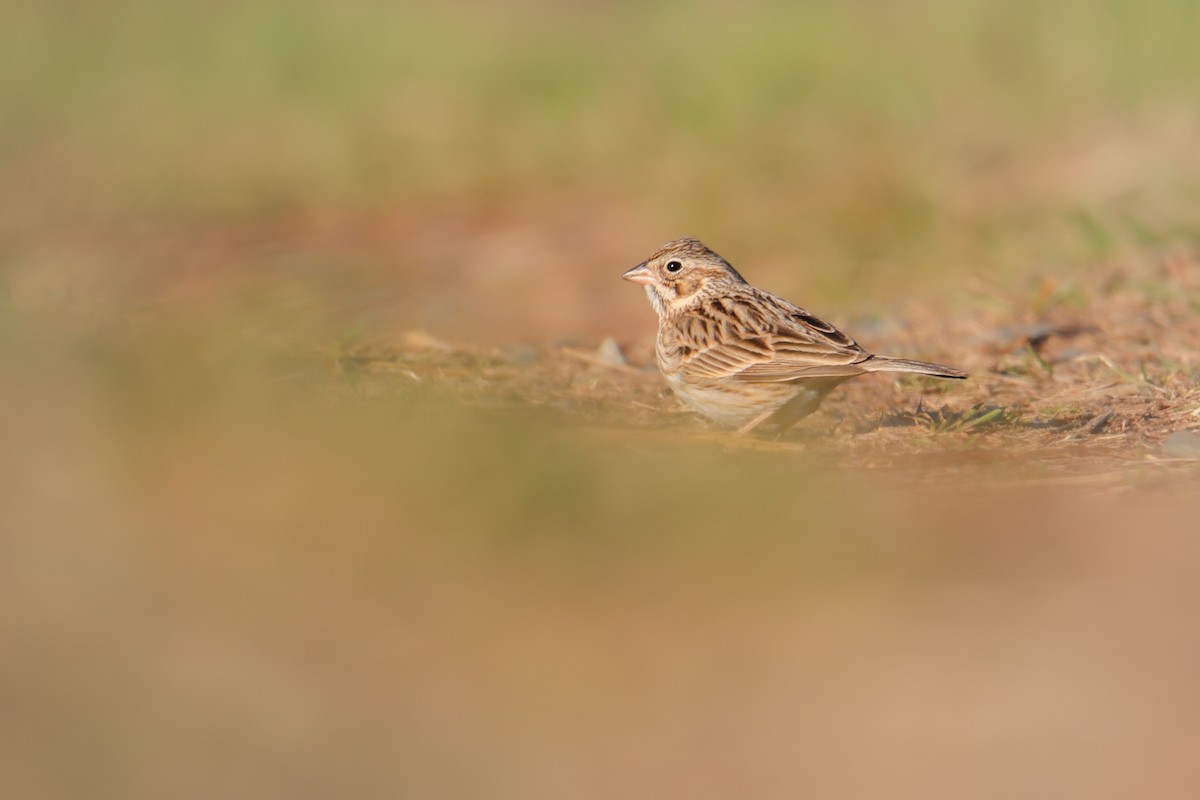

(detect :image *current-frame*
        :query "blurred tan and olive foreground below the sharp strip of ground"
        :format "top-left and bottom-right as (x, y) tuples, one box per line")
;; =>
(0, 297), (1200, 798)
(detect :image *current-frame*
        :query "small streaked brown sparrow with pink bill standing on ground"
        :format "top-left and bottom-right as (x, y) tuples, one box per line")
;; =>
(623, 239), (967, 433)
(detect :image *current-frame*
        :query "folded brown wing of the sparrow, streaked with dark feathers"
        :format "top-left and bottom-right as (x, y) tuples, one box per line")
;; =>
(676, 290), (871, 383)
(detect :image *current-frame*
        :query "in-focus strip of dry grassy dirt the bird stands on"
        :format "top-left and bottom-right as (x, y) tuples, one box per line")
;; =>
(326, 248), (1200, 489)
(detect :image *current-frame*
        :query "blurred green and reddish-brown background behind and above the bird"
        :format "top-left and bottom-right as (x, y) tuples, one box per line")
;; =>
(7, 0), (1200, 326)
